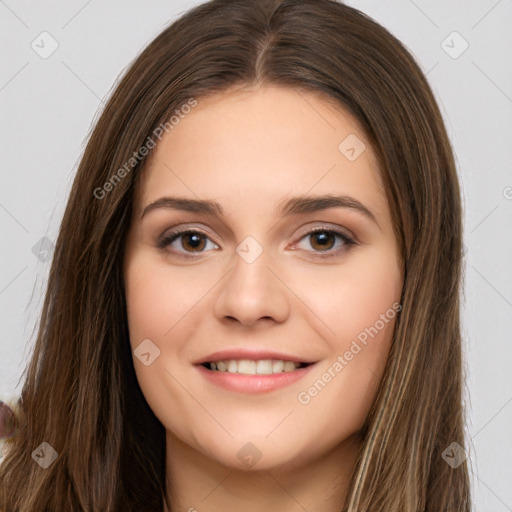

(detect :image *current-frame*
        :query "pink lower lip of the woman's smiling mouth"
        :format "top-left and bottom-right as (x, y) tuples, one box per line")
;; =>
(197, 364), (314, 393)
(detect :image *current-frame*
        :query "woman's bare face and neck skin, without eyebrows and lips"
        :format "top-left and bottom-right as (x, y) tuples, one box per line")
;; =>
(124, 86), (403, 512)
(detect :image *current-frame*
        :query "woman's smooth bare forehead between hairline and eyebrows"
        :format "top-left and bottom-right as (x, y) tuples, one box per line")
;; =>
(134, 86), (386, 220)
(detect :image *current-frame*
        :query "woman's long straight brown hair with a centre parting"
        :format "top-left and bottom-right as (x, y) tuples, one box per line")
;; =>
(0, 0), (470, 512)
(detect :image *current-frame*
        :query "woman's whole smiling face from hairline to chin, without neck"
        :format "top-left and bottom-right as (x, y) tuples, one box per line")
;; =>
(124, 86), (402, 469)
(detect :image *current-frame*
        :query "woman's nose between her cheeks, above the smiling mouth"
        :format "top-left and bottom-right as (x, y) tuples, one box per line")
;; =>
(214, 251), (290, 326)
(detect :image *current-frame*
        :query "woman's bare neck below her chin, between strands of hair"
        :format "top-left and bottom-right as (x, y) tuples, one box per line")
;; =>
(165, 432), (360, 512)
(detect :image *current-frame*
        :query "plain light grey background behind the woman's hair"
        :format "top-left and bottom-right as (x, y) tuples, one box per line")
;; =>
(0, 0), (512, 512)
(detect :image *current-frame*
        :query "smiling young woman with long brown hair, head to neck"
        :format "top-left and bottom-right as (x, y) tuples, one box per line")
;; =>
(0, 0), (470, 512)
